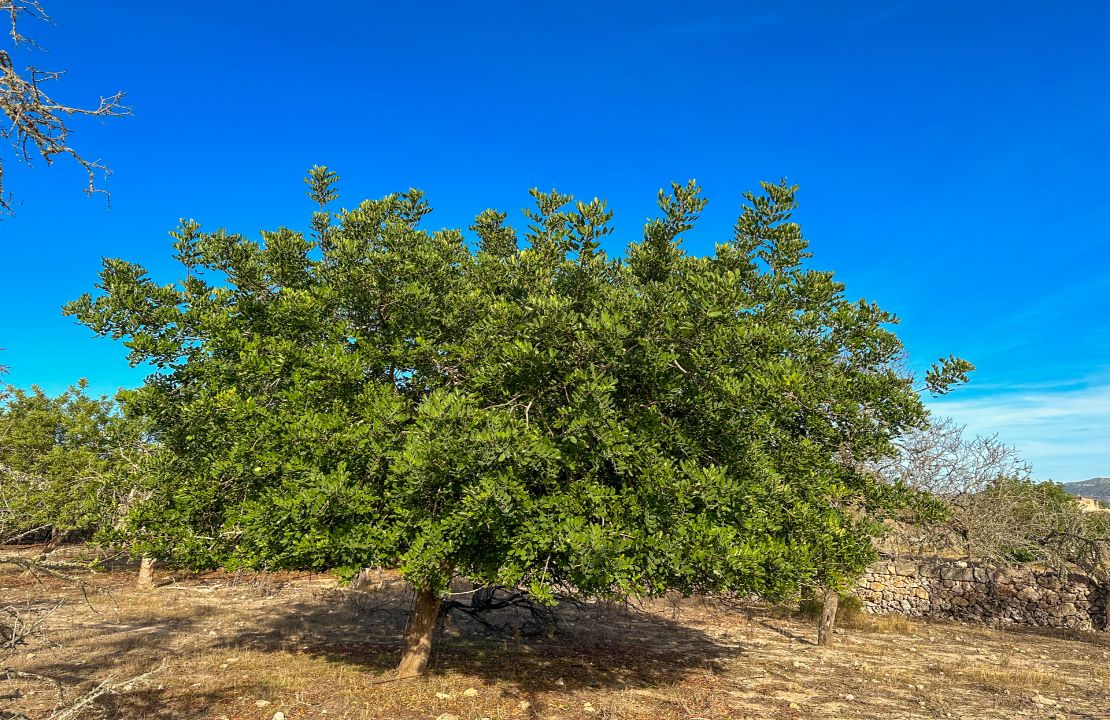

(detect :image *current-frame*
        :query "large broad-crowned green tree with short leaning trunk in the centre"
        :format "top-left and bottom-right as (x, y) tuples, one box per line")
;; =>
(67, 168), (967, 675)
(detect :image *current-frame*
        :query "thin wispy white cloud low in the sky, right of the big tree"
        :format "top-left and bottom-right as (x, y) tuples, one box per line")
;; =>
(927, 379), (1110, 483)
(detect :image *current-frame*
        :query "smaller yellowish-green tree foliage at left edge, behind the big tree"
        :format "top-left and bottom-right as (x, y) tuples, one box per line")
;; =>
(0, 381), (138, 538)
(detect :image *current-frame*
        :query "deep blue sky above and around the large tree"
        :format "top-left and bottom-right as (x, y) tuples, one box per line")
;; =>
(0, 0), (1110, 481)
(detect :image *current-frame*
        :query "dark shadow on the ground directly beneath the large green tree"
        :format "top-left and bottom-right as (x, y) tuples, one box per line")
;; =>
(216, 585), (741, 692)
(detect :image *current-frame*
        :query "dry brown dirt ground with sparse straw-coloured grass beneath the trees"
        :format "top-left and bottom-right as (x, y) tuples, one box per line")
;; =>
(0, 552), (1110, 720)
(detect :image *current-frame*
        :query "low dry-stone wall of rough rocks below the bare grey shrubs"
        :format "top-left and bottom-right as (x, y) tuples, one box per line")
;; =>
(856, 559), (1110, 630)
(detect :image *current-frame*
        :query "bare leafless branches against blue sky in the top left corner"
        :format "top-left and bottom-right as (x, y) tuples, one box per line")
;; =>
(0, 0), (131, 213)
